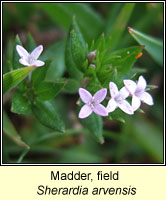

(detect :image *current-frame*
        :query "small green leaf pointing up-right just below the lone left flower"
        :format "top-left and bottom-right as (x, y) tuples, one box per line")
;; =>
(31, 59), (52, 87)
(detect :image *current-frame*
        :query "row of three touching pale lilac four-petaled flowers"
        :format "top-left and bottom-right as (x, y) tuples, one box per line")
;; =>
(79, 76), (153, 118)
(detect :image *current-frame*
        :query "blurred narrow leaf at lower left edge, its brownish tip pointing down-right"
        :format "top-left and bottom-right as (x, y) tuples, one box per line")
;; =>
(3, 111), (30, 149)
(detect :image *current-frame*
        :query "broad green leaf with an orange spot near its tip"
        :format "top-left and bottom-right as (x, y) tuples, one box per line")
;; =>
(97, 46), (144, 88)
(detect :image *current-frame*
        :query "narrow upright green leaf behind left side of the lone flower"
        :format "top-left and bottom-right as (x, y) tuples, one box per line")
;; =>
(12, 35), (23, 69)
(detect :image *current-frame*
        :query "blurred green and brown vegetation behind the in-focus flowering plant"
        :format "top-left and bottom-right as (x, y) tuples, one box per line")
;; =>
(2, 3), (164, 164)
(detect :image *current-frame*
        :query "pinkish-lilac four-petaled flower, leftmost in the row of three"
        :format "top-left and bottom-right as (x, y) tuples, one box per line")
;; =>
(78, 88), (108, 118)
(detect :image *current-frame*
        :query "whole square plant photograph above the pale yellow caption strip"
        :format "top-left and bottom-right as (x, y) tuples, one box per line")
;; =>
(2, 2), (164, 164)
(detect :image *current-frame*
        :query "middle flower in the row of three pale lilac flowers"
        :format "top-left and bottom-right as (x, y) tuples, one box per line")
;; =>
(106, 82), (134, 115)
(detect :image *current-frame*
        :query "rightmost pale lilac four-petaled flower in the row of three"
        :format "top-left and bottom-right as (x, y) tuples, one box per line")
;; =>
(123, 76), (153, 111)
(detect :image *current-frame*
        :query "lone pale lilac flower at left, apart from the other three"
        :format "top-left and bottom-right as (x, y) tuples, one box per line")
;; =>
(16, 45), (45, 67)
